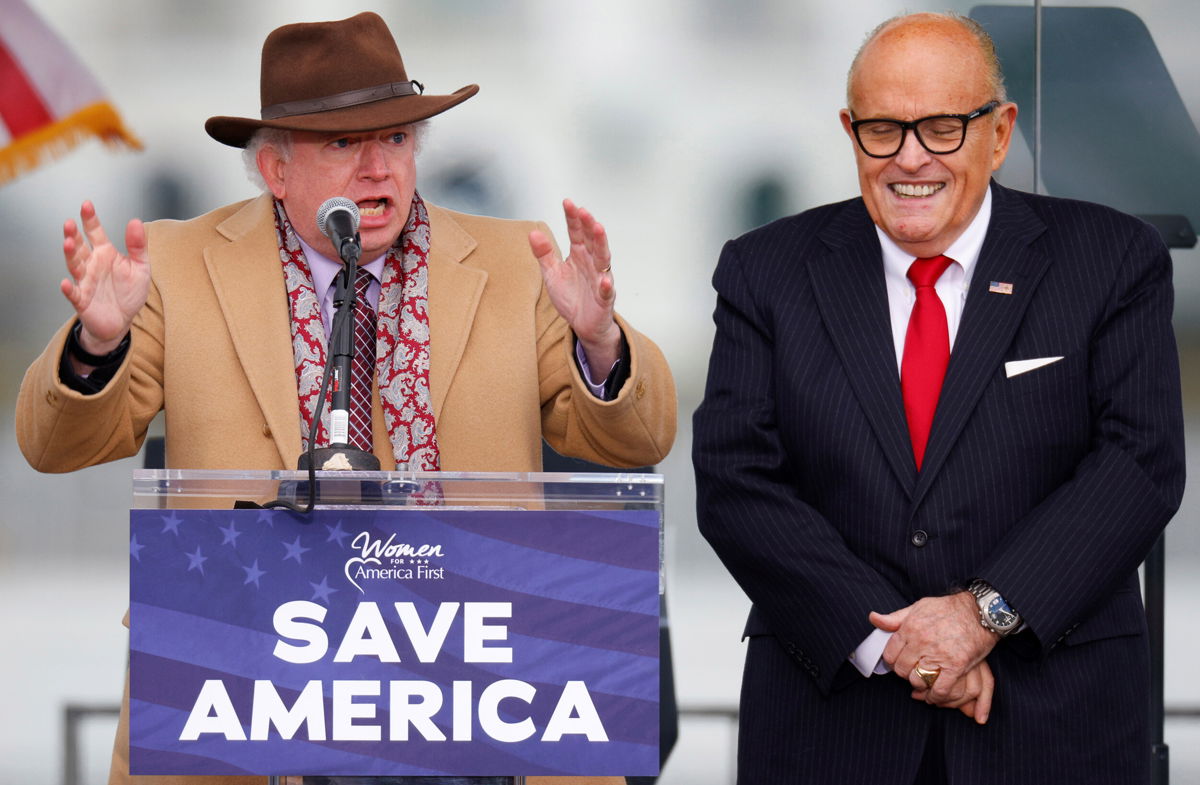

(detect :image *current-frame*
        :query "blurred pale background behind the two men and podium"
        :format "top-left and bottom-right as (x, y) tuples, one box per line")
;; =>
(0, 0), (1200, 785)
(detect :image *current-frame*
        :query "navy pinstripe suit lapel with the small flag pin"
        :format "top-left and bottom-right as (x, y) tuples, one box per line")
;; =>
(913, 185), (1050, 509)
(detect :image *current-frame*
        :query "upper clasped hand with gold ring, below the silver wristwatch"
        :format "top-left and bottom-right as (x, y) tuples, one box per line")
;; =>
(870, 592), (1000, 706)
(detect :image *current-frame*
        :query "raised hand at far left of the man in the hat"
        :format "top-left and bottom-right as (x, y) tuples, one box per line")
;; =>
(59, 202), (150, 371)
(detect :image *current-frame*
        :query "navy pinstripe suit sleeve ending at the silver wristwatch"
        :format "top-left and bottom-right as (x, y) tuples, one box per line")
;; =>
(979, 219), (1184, 653)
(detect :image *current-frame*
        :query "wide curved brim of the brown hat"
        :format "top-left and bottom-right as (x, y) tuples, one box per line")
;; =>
(204, 84), (479, 148)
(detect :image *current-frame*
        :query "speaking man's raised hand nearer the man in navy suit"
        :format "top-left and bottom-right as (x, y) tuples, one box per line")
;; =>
(529, 199), (620, 377)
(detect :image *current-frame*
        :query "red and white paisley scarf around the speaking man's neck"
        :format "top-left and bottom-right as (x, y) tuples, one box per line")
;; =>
(275, 192), (440, 472)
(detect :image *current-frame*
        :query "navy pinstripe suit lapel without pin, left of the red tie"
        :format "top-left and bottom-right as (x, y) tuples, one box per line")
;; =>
(809, 200), (916, 495)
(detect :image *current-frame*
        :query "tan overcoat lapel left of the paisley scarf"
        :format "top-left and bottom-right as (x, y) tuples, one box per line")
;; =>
(204, 196), (300, 468)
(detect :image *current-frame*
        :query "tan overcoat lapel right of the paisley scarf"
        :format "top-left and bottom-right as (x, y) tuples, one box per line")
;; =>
(426, 203), (487, 420)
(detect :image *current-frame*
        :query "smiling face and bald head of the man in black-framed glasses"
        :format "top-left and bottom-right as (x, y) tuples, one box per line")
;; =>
(841, 16), (1016, 257)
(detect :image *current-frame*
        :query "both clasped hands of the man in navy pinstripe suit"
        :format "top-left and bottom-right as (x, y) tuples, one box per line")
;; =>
(870, 592), (1000, 725)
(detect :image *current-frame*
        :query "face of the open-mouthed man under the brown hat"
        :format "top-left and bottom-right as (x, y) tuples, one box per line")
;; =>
(258, 125), (416, 260)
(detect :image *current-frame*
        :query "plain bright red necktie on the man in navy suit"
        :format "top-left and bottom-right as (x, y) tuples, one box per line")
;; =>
(900, 256), (953, 471)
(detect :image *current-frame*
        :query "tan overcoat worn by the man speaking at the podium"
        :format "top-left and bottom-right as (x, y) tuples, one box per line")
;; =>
(17, 196), (676, 785)
